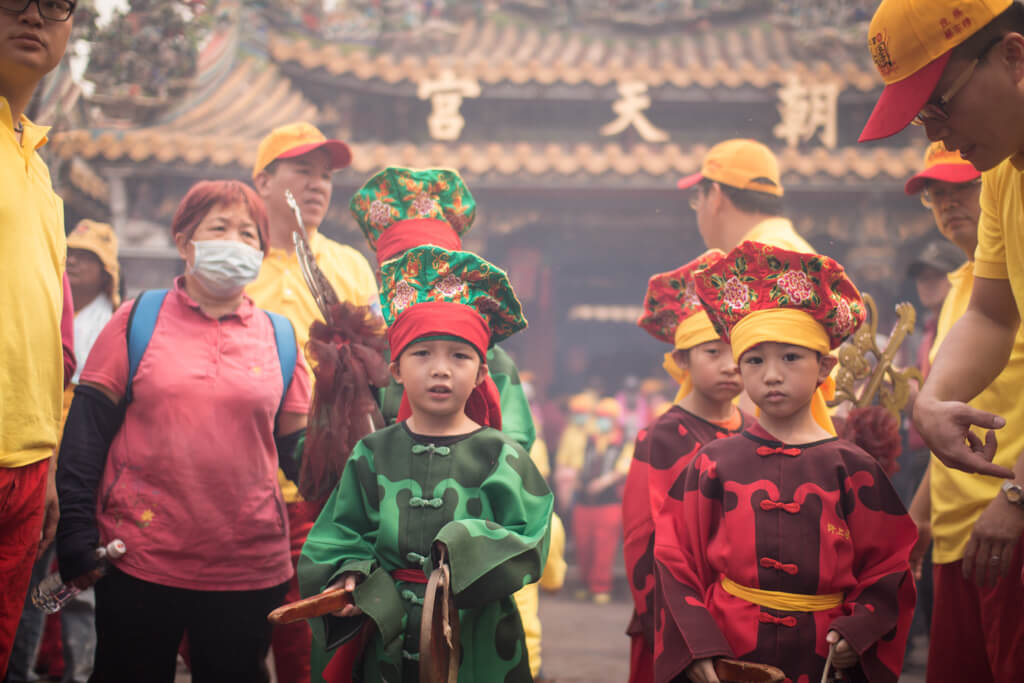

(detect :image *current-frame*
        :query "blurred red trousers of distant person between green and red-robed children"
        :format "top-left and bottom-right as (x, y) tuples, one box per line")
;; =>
(572, 503), (623, 593)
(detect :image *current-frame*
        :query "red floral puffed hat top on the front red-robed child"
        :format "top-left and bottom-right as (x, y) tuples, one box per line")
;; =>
(694, 242), (865, 348)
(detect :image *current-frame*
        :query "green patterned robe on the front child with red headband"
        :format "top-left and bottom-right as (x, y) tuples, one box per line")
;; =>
(298, 422), (553, 683)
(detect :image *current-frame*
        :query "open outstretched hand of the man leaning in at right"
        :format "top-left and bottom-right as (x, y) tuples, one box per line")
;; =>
(913, 396), (1014, 479)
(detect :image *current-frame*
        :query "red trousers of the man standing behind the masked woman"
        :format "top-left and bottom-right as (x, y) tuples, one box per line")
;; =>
(270, 501), (319, 683)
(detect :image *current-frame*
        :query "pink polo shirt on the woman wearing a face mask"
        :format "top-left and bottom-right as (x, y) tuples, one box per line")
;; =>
(81, 278), (309, 591)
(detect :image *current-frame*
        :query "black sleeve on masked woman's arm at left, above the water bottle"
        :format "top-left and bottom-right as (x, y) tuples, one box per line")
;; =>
(56, 385), (125, 580)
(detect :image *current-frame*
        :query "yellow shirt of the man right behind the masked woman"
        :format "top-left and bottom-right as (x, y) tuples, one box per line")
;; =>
(246, 231), (379, 503)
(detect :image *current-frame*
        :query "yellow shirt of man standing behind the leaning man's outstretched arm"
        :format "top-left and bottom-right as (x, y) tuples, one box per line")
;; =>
(931, 263), (1024, 564)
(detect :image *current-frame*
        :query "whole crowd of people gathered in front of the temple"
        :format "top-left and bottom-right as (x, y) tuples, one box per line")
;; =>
(6, 0), (1024, 683)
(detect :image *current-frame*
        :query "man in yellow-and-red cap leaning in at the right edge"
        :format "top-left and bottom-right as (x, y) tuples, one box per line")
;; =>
(860, 0), (1024, 493)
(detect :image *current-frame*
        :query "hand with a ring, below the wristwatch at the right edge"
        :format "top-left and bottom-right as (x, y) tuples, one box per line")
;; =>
(964, 493), (1024, 586)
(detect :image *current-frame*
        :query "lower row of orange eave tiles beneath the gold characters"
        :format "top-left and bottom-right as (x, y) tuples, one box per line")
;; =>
(52, 132), (921, 180)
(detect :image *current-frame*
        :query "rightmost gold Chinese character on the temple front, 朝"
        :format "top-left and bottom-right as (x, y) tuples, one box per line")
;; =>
(773, 77), (839, 150)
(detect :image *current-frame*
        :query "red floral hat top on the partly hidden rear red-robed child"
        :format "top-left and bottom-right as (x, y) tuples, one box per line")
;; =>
(637, 249), (725, 344)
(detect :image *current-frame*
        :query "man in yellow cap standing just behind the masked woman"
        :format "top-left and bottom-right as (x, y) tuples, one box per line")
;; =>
(246, 122), (379, 683)
